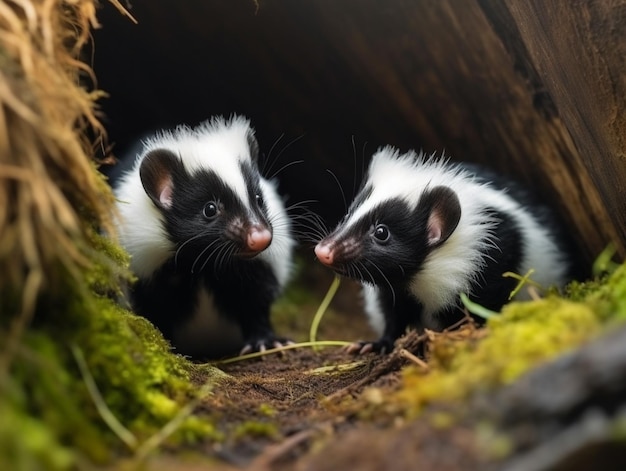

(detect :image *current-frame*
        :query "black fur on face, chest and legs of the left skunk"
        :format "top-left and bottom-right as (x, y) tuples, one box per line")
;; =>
(117, 145), (286, 356)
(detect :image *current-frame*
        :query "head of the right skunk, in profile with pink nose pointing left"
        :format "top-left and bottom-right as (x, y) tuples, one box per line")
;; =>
(315, 147), (461, 285)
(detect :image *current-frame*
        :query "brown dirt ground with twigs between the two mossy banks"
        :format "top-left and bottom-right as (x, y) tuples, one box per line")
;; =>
(147, 266), (488, 471)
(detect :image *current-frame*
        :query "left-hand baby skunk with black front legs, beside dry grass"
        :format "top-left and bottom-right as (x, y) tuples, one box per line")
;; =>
(113, 116), (294, 357)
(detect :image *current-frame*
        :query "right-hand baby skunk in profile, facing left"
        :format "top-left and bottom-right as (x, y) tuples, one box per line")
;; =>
(315, 147), (569, 353)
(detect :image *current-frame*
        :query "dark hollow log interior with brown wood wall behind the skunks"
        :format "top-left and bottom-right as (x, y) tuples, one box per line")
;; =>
(94, 0), (626, 270)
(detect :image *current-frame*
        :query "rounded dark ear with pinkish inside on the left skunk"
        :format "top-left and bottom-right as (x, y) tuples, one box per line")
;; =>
(139, 149), (183, 209)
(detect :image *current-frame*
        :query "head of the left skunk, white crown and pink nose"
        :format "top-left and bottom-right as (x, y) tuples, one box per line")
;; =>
(139, 118), (272, 272)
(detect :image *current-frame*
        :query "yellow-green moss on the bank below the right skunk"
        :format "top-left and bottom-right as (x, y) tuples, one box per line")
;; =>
(401, 298), (600, 411)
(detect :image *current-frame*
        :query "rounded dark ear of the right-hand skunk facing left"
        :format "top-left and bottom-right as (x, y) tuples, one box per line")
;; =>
(420, 186), (461, 247)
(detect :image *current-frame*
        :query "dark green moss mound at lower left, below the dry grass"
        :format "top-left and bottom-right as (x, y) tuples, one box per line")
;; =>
(0, 233), (224, 470)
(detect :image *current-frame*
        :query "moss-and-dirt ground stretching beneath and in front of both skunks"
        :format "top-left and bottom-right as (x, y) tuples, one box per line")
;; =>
(0, 242), (626, 470)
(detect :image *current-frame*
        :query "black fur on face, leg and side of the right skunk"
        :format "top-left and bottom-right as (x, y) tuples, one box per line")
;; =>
(316, 159), (567, 352)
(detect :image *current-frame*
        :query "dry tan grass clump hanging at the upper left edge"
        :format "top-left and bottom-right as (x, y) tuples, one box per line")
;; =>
(0, 0), (112, 356)
